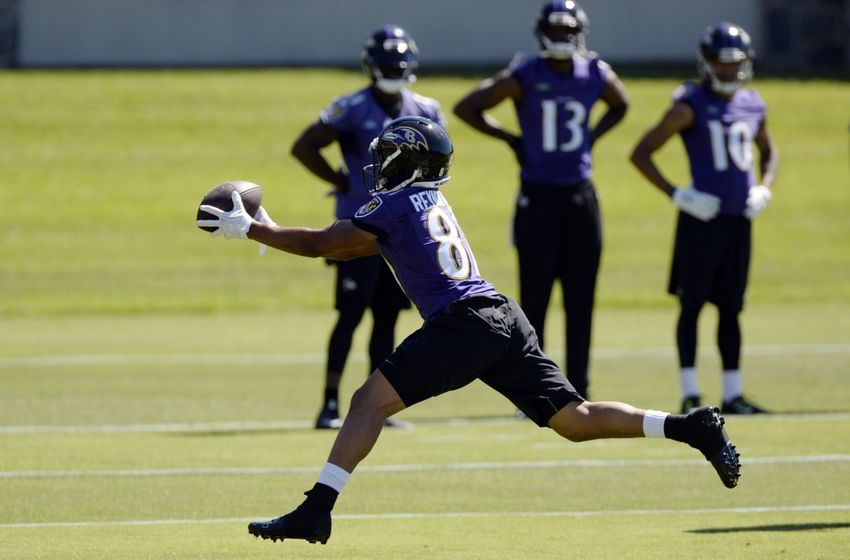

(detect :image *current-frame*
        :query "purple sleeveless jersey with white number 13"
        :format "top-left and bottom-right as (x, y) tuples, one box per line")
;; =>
(510, 53), (611, 185)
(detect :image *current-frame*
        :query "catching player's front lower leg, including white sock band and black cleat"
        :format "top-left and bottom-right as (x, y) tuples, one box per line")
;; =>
(248, 370), (404, 544)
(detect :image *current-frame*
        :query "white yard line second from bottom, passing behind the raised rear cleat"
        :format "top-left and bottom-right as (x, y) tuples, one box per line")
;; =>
(0, 455), (850, 480)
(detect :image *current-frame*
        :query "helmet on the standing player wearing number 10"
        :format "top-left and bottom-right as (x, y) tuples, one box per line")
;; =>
(697, 21), (755, 95)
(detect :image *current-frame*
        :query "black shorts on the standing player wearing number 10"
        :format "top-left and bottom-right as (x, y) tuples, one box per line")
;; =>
(668, 212), (752, 311)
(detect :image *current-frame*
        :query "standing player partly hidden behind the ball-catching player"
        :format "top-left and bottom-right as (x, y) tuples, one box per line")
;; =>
(292, 25), (445, 429)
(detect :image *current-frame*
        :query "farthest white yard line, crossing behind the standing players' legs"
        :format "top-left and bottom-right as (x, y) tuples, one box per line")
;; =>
(0, 344), (850, 369)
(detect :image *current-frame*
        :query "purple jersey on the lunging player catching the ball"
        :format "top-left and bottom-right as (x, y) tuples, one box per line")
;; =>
(352, 187), (496, 321)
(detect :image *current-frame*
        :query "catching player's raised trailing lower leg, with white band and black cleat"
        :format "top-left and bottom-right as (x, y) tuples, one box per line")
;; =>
(549, 401), (741, 488)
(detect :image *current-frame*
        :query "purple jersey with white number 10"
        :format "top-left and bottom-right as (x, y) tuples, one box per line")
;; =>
(673, 83), (765, 215)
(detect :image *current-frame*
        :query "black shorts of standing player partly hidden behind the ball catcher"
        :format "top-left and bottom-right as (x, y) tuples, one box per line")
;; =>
(328, 255), (410, 311)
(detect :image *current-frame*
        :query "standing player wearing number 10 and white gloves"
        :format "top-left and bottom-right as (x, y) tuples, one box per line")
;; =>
(631, 22), (778, 414)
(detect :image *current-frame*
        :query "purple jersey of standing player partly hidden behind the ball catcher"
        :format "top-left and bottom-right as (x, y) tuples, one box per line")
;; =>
(319, 87), (446, 218)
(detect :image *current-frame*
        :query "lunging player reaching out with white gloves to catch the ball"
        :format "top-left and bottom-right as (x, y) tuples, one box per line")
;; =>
(198, 117), (740, 543)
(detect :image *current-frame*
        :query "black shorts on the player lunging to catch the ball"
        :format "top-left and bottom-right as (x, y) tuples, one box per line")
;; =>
(380, 295), (584, 427)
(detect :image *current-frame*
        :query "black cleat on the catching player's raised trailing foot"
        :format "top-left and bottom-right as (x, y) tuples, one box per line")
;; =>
(687, 406), (741, 488)
